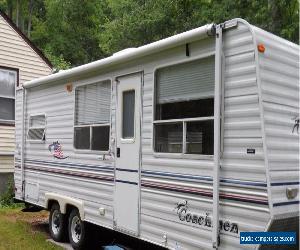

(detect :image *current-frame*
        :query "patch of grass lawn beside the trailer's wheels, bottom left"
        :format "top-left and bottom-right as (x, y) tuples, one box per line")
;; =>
(0, 208), (62, 250)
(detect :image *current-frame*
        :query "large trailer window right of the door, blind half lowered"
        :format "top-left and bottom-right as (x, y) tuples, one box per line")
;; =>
(154, 56), (215, 155)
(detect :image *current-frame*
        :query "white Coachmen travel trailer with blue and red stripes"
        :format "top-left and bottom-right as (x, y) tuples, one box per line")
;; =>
(15, 19), (299, 249)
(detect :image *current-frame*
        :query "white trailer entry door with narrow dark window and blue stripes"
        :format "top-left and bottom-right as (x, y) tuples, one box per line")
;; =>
(114, 73), (142, 235)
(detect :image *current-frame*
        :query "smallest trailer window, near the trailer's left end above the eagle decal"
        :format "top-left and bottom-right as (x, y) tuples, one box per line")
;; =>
(28, 115), (46, 141)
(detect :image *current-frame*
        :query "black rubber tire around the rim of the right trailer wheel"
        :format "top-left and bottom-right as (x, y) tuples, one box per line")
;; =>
(68, 209), (91, 250)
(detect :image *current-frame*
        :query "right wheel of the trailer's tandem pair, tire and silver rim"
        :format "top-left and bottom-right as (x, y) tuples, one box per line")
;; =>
(68, 209), (91, 250)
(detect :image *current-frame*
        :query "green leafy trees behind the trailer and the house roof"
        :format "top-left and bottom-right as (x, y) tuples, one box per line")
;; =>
(0, 0), (299, 69)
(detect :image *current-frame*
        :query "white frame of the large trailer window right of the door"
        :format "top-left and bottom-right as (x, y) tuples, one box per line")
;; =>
(151, 51), (215, 159)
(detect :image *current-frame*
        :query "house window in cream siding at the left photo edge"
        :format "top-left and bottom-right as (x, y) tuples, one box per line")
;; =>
(0, 68), (17, 123)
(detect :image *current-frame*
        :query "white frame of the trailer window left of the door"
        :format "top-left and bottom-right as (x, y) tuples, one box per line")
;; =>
(73, 78), (113, 154)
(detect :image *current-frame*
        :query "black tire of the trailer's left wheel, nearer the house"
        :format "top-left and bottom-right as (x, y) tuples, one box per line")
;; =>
(49, 203), (67, 242)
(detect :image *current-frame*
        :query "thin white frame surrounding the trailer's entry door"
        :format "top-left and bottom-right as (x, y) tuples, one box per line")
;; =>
(112, 70), (144, 236)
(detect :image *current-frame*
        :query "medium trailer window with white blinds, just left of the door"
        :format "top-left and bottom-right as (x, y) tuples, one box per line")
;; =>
(74, 81), (111, 151)
